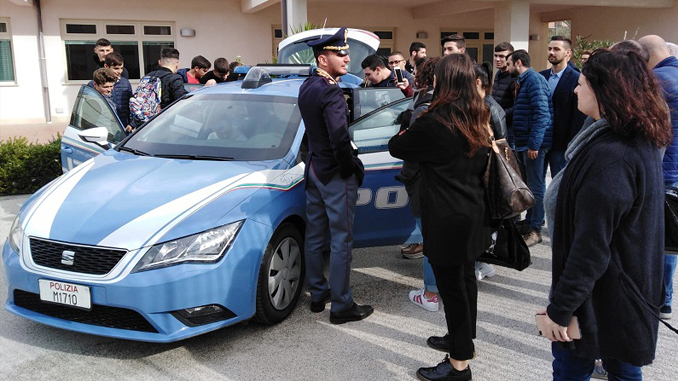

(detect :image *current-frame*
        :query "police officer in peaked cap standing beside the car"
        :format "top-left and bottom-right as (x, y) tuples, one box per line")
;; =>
(299, 28), (374, 324)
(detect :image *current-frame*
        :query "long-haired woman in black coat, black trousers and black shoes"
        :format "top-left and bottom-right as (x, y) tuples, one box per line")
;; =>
(389, 54), (491, 380)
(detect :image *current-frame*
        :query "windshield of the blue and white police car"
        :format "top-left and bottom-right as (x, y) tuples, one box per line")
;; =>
(123, 94), (301, 160)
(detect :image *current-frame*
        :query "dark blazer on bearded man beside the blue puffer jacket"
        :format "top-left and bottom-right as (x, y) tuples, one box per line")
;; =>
(539, 66), (586, 151)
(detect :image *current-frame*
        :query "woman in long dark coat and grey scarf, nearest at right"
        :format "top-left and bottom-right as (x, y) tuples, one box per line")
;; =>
(539, 49), (672, 380)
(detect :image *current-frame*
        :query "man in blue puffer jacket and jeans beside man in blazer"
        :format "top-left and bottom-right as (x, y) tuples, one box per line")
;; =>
(507, 49), (553, 246)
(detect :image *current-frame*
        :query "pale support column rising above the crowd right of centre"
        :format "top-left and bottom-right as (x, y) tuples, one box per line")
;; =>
(494, 1), (530, 50)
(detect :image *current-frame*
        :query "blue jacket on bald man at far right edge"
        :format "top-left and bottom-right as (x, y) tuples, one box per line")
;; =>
(653, 56), (678, 185)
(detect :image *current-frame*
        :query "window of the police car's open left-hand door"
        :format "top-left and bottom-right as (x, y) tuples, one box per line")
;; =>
(71, 86), (125, 144)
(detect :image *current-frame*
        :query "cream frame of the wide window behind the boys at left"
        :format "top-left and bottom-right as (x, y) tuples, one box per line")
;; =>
(61, 19), (177, 85)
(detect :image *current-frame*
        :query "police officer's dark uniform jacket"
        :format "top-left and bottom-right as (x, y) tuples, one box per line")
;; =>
(299, 69), (364, 184)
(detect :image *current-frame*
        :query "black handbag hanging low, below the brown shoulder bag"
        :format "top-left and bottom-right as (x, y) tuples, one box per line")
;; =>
(478, 219), (532, 271)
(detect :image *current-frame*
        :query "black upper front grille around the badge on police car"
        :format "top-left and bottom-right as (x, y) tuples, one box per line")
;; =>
(30, 238), (127, 275)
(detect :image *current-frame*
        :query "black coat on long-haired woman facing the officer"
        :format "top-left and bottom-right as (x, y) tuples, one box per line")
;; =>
(388, 111), (492, 266)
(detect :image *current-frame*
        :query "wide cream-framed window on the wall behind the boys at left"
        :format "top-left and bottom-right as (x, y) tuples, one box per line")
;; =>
(61, 20), (174, 83)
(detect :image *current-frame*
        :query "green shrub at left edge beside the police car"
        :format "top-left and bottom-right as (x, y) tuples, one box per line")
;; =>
(0, 135), (62, 195)
